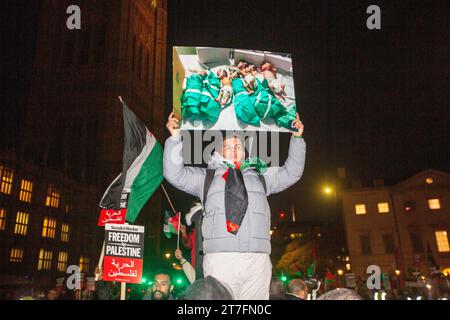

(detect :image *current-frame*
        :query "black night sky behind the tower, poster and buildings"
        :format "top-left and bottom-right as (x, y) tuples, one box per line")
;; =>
(1, 0), (450, 219)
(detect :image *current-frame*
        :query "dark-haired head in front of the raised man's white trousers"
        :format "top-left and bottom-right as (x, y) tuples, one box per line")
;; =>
(182, 276), (234, 300)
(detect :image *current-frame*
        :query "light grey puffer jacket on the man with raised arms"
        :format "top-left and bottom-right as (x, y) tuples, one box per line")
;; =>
(163, 136), (306, 254)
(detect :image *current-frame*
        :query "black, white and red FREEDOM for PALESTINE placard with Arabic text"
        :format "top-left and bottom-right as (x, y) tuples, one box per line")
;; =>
(103, 224), (144, 284)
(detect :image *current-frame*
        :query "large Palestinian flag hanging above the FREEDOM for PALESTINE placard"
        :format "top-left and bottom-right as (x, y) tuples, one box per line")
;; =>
(100, 100), (163, 223)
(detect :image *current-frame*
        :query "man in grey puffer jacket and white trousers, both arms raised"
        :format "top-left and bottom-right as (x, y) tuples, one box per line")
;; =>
(163, 113), (306, 300)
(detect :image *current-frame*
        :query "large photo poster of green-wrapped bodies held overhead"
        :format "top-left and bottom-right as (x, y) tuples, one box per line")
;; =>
(174, 47), (297, 131)
